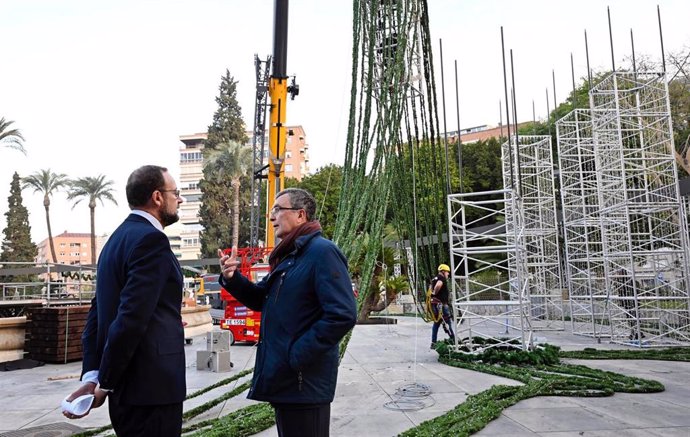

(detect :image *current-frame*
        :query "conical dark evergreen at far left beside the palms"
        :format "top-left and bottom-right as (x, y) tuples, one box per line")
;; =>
(0, 172), (38, 282)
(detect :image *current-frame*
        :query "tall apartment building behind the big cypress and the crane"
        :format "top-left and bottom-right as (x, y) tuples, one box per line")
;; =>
(165, 125), (310, 260)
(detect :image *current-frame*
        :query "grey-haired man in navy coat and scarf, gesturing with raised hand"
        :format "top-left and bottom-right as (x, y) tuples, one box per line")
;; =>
(218, 188), (357, 437)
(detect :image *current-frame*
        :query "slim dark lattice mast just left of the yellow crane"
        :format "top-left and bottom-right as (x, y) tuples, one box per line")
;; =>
(249, 55), (271, 247)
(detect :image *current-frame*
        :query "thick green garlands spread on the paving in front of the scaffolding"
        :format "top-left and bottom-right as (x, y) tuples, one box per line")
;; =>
(400, 342), (668, 437)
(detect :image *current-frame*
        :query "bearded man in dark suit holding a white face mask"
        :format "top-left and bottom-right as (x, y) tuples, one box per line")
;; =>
(63, 165), (186, 437)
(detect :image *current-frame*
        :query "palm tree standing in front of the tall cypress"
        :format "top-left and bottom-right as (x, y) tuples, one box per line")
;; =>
(205, 141), (254, 247)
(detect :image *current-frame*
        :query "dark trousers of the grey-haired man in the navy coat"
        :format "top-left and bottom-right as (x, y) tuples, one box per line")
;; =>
(272, 403), (331, 437)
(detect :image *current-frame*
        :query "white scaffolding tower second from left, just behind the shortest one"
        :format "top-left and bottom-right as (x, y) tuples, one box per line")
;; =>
(501, 136), (565, 330)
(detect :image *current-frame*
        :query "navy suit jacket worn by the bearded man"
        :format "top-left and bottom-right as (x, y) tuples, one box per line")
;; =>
(82, 214), (186, 405)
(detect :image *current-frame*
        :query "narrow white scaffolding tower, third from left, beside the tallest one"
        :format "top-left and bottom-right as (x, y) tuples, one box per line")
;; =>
(556, 109), (609, 338)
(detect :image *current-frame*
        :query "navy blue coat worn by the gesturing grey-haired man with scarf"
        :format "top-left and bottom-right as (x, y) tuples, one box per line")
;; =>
(220, 232), (357, 404)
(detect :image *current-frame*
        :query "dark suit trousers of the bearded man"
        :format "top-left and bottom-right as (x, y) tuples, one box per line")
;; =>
(108, 393), (182, 437)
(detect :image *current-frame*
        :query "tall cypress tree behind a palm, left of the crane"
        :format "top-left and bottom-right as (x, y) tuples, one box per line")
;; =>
(199, 70), (251, 258)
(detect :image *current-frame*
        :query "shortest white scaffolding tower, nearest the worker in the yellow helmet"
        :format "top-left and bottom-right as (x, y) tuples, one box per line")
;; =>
(448, 189), (532, 352)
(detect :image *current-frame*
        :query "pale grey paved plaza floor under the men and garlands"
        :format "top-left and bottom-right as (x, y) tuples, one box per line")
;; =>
(0, 317), (690, 437)
